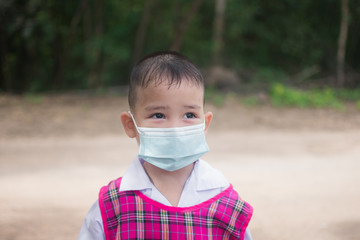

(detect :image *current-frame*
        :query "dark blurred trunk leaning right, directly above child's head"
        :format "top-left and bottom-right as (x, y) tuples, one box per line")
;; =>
(170, 0), (202, 51)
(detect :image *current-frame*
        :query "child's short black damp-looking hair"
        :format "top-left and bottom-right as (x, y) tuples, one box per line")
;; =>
(128, 51), (204, 111)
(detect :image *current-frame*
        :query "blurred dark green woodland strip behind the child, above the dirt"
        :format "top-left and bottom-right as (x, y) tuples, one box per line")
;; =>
(0, 0), (360, 100)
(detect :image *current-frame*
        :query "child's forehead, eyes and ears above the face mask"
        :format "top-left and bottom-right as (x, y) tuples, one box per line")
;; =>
(122, 80), (212, 140)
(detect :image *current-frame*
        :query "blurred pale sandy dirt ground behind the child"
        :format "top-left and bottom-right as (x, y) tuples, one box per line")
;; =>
(0, 95), (360, 240)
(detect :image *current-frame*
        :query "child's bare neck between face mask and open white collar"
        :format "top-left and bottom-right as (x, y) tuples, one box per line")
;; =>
(143, 162), (194, 206)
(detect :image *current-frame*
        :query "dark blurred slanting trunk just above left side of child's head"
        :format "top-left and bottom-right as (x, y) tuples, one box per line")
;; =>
(133, 0), (155, 64)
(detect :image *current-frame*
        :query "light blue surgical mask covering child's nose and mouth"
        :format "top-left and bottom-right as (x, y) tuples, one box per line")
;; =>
(130, 113), (209, 171)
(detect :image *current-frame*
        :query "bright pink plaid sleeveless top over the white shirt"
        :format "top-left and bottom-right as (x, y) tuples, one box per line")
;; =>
(99, 178), (253, 240)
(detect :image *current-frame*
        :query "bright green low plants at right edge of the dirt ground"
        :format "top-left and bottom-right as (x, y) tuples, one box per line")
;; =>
(270, 83), (343, 109)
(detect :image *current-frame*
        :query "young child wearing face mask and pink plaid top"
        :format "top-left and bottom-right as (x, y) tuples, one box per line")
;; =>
(78, 52), (253, 240)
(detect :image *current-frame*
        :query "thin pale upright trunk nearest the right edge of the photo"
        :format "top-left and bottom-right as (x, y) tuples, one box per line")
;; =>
(337, 0), (349, 87)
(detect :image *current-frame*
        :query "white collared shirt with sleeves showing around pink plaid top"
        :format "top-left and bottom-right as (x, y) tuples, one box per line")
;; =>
(78, 158), (252, 240)
